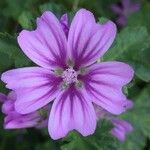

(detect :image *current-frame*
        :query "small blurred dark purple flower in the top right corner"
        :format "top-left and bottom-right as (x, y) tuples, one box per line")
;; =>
(111, 0), (140, 26)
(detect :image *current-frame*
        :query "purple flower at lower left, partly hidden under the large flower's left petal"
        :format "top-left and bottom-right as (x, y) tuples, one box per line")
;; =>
(2, 92), (47, 129)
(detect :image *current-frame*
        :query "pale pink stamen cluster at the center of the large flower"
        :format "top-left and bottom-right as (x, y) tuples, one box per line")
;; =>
(62, 67), (77, 85)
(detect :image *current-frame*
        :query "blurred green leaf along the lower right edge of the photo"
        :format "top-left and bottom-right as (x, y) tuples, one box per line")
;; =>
(118, 85), (150, 150)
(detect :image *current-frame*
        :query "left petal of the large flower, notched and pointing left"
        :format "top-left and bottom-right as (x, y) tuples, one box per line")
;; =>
(2, 67), (62, 114)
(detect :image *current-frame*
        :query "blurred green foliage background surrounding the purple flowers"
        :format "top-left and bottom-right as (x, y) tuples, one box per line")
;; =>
(0, 0), (150, 150)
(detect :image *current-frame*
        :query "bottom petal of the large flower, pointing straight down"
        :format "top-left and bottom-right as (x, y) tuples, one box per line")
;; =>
(48, 88), (96, 139)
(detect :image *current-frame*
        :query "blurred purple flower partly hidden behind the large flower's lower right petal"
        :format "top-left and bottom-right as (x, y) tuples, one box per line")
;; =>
(94, 101), (133, 141)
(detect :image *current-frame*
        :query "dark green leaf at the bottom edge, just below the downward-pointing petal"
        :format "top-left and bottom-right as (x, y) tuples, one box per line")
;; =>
(61, 120), (117, 150)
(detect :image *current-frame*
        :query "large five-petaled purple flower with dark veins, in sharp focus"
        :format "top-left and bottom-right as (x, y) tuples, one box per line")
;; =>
(2, 9), (133, 139)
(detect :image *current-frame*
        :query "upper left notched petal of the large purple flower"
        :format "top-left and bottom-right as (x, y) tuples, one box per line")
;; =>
(18, 11), (67, 69)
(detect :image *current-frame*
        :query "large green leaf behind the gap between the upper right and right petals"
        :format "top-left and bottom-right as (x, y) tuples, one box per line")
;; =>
(103, 27), (150, 82)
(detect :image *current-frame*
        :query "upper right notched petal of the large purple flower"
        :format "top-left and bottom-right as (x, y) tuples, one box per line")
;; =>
(68, 9), (116, 69)
